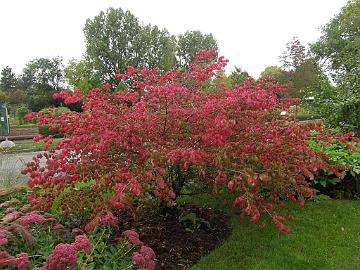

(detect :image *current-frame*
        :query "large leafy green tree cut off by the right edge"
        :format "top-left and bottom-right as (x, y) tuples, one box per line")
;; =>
(311, 0), (360, 134)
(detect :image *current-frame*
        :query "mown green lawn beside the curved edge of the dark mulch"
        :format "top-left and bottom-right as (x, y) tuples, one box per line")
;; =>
(180, 194), (360, 270)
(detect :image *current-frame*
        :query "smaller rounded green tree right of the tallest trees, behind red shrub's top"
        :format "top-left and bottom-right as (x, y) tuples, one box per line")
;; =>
(176, 31), (219, 68)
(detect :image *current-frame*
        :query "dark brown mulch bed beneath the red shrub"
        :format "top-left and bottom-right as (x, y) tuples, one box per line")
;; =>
(117, 205), (230, 270)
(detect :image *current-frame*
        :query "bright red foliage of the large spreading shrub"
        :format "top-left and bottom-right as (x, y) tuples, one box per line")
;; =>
(23, 51), (344, 232)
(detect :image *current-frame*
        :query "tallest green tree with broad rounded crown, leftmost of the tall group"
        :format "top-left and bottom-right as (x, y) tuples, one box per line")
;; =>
(84, 8), (144, 80)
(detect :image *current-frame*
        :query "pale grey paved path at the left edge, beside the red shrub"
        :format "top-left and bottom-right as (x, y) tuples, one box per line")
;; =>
(0, 152), (43, 183)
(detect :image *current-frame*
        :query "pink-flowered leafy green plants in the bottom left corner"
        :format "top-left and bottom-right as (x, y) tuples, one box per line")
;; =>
(0, 186), (155, 270)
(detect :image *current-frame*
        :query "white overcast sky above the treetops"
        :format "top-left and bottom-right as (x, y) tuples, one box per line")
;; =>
(0, 0), (347, 77)
